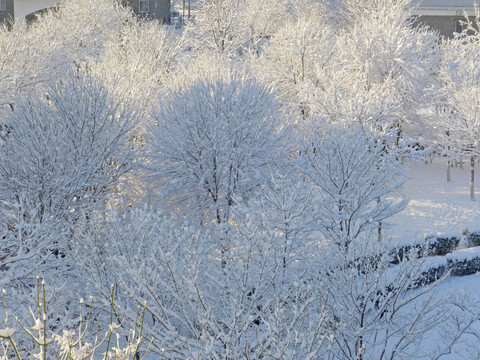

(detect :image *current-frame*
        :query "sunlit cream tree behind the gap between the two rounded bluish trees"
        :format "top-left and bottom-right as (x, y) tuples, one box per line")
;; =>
(90, 20), (185, 204)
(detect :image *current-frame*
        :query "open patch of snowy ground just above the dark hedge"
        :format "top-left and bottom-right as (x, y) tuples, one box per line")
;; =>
(390, 159), (480, 243)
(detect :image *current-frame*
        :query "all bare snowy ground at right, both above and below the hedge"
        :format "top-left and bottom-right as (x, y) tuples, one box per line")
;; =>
(390, 159), (480, 360)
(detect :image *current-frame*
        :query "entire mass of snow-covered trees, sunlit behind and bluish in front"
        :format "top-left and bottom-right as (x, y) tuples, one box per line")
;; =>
(0, 0), (480, 360)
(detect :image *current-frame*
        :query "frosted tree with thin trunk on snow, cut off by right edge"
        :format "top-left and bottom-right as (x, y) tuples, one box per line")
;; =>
(430, 8), (480, 200)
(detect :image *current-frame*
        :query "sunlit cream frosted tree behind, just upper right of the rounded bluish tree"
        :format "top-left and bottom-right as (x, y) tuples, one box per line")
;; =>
(254, 1), (335, 123)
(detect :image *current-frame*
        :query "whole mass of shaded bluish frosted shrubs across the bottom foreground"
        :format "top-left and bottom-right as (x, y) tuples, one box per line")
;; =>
(72, 200), (480, 359)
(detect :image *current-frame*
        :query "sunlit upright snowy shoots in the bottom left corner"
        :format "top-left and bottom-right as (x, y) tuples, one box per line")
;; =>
(0, 278), (146, 360)
